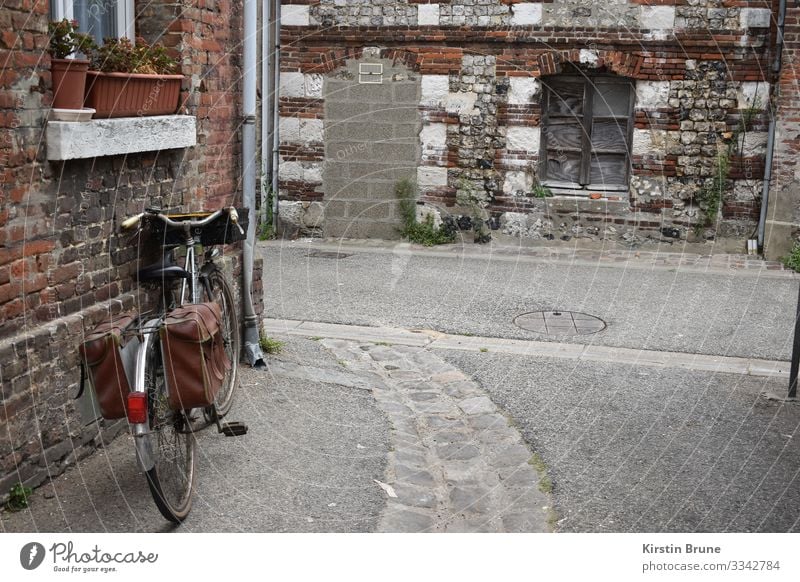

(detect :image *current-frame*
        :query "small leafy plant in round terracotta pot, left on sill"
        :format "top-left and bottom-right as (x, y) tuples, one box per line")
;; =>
(47, 18), (95, 109)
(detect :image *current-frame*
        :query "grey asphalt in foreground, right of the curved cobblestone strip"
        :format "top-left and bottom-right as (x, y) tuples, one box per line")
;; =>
(437, 350), (800, 532)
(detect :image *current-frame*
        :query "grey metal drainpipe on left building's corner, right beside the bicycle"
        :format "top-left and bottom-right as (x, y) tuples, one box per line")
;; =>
(242, 0), (266, 368)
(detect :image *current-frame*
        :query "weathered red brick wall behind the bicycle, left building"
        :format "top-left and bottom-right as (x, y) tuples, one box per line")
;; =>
(0, 0), (260, 499)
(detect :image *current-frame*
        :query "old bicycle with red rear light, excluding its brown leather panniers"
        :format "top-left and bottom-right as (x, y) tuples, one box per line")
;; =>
(122, 207), (247, 523)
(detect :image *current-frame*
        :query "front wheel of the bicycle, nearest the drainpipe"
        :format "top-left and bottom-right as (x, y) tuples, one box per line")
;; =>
(204, 269), (242, 418)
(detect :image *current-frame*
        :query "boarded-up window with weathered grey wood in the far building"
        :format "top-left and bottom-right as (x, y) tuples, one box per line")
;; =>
(541, 74), (634, 195)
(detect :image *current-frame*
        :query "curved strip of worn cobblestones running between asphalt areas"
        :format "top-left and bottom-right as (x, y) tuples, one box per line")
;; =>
(316, 339), (554, 532)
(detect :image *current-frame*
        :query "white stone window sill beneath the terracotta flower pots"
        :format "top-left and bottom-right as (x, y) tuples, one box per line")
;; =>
(47, 115), (197, 161)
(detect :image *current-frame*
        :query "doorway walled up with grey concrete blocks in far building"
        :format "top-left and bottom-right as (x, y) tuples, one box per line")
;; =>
(322, 57), (421, 239)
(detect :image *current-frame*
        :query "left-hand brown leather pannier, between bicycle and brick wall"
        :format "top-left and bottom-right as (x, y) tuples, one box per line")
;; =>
(79, 315), (133, 420)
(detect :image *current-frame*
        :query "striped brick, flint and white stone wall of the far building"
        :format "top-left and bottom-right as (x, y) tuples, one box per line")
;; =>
(281, 0), (774, 248)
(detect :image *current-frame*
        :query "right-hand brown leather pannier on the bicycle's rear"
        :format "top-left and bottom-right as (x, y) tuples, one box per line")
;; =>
(160, 303), (231, 410)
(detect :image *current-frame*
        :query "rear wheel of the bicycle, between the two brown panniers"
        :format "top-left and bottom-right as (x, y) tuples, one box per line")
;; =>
(145, 334), (196, 523)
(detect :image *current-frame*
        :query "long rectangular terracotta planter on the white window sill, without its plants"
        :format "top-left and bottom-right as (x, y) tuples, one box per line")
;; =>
(86, 71), (183, 119)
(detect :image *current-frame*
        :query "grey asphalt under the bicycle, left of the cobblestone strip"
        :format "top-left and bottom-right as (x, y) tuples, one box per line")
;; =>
(0, 339), (389, 532)
